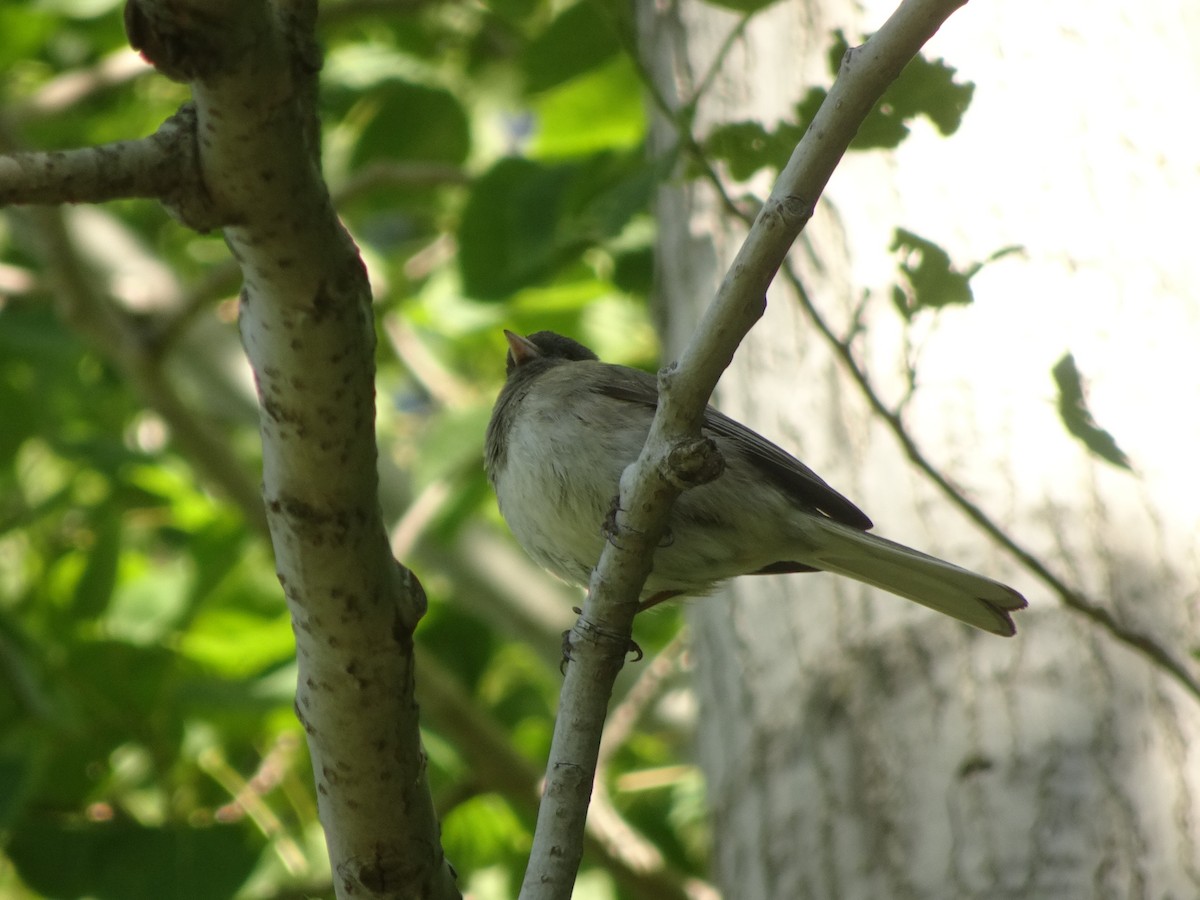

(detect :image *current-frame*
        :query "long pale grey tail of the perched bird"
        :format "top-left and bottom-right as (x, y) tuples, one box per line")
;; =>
(805, 520), (1027, 637)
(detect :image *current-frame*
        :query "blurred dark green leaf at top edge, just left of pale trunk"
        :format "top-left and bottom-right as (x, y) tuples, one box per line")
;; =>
(521, 0), (620, 94)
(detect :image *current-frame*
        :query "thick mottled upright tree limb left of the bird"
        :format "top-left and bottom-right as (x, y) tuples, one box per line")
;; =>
(126, 0), (458, 899)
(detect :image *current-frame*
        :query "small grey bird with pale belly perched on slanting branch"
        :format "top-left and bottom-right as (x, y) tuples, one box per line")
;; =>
(485, 331), (1026, 636)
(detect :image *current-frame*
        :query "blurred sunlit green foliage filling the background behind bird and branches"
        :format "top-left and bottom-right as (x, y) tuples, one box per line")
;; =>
(0, 0), (993, 900)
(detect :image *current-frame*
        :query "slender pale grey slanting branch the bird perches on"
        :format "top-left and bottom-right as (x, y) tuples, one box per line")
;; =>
(521, 0), (965, 900)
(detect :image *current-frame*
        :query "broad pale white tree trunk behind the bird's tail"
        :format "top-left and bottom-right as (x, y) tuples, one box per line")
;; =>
(641, 0), (1200, 900)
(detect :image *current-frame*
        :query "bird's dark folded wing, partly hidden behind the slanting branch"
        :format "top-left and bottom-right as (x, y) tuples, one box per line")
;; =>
(596, 365), (872, 532)
